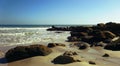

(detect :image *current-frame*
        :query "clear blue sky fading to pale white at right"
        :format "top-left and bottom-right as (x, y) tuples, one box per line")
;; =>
(0, 0), (120, 24)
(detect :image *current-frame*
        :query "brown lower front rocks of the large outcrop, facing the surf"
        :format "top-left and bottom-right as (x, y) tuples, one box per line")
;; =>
(68, 30), (116, 44)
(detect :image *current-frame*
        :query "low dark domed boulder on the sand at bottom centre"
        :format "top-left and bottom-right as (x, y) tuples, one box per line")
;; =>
(52, 56), (75, 64)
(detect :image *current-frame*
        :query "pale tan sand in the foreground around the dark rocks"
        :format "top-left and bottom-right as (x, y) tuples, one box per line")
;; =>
(0, 44), (120, 66)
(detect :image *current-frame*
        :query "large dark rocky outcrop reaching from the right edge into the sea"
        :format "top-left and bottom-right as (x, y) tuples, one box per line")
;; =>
(48, 22), (120, 44)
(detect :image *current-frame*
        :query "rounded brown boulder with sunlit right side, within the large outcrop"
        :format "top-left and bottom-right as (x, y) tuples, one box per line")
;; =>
(90, 30), (116, 43)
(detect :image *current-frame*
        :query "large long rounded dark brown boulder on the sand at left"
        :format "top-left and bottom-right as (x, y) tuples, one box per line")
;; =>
(5, 45), (52, 62)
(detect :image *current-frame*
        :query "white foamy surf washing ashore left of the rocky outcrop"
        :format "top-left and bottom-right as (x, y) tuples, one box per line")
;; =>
(0, 26), (70, 46)
